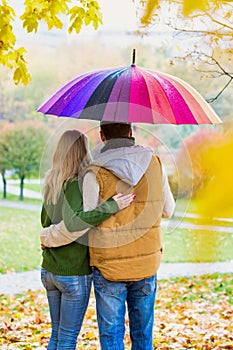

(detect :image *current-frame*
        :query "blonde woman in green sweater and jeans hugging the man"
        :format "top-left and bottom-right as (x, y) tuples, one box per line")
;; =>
(41, 130), (134, 350)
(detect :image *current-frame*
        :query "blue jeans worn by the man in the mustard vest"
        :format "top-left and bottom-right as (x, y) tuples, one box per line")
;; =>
(93, 268), (157, 350)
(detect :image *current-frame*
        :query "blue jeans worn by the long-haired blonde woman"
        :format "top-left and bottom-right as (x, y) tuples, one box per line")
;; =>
(41, 268), (92, 350)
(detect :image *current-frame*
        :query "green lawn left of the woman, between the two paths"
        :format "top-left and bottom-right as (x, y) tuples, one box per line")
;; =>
(0, 207), (41, 273)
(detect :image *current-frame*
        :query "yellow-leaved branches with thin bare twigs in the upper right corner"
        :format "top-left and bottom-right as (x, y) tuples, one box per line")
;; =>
(138, 0), (233, 102)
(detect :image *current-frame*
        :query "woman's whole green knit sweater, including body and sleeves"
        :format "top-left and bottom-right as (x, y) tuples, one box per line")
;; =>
(41, 178), (119, 276)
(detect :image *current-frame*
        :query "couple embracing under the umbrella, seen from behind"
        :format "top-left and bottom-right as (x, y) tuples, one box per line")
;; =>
(41, 122), (174, 350)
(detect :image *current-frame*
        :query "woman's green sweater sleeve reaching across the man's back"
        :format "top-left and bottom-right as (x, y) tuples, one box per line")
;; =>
(62, 179), (119, 232)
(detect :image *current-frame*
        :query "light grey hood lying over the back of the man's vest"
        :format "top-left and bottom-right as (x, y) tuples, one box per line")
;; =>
(92, 145), (153, 186)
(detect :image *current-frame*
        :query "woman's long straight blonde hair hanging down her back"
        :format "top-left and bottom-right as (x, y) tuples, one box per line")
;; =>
(43, 130), (91, 204)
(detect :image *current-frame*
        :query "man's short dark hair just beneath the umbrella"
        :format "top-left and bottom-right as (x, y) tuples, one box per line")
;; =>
(100, 122), (131, 140)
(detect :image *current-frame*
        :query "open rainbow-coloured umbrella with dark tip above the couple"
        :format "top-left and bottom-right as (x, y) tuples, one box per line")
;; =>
(38, 52), (221, 124)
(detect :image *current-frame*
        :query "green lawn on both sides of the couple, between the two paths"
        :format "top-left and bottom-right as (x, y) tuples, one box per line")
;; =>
(0, 207), (233, 273)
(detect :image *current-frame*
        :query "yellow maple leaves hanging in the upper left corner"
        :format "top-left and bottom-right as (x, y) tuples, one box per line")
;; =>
(0, 0), (102, 85)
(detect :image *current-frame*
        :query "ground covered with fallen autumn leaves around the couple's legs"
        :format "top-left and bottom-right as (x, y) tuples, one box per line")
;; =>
(0, 274), (233, 350)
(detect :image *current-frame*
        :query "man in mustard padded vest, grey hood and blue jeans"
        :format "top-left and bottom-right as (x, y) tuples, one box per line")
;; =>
(41, 122), (174, 350)
